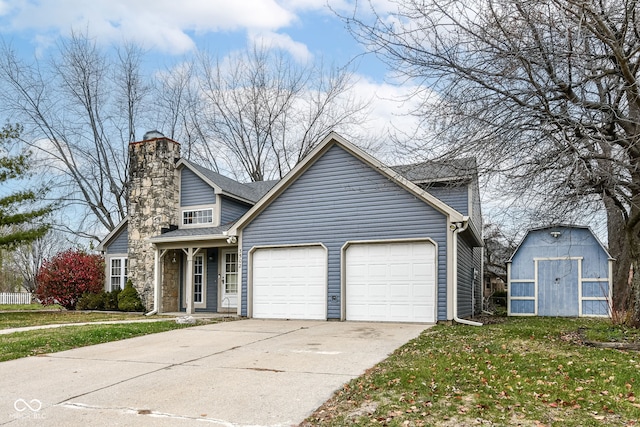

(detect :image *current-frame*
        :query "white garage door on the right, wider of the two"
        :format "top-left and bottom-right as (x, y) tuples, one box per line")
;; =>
(345, 242), (436, 322)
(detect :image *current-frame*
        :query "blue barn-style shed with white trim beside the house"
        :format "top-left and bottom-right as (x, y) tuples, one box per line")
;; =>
(507, 225), (613, 316)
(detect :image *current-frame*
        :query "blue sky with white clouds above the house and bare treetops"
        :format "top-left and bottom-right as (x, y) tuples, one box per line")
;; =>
(0, 0), (415, 157)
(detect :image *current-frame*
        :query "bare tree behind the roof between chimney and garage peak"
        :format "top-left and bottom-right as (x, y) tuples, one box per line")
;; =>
(199, 46), (368, 181)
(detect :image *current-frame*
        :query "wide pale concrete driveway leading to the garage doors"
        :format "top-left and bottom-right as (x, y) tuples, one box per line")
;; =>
(0, 320), (428, 426)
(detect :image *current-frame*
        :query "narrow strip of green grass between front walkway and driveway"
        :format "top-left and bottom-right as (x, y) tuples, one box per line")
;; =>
(0, 320), (199, 362)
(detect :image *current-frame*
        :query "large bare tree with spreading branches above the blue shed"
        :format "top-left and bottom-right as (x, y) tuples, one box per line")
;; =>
(345, 0), (640, 324)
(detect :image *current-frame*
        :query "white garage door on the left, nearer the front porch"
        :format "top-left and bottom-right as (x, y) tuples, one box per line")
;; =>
(251, 246), (327, 320)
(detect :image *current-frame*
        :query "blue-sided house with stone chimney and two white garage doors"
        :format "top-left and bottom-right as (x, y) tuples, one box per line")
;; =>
(99, 133), (482, 322)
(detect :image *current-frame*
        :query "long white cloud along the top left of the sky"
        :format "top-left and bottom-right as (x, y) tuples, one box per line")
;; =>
(0, 0), (296, 53)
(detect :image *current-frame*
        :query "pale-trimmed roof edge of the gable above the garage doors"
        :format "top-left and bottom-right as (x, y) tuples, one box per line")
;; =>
(229, 132), (467, 235)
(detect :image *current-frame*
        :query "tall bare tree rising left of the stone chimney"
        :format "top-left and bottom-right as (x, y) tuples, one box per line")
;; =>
(0, 33), (148, 239)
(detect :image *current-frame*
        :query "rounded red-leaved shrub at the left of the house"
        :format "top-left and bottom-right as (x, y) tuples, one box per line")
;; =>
(36, 249), (104, 310)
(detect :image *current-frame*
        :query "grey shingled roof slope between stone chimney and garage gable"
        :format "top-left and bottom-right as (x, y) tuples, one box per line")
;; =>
(176, 159), (277, 204)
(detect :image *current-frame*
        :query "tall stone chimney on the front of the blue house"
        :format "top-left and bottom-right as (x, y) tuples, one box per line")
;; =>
(128, 131), (180, 310)
